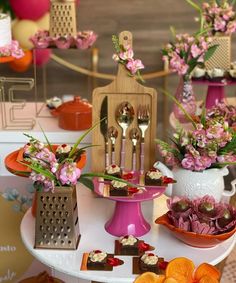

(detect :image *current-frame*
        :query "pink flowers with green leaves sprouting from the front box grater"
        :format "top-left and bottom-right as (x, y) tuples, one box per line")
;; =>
(21, 136), (84, 191)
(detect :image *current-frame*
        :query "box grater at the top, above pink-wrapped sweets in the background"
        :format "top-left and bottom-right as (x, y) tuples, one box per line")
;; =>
(49, 0), (77, 37)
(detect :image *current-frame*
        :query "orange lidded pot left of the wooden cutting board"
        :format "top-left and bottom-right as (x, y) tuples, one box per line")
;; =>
(51, 96), (92, 131)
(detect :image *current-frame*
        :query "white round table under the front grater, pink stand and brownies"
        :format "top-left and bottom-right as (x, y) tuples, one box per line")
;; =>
(21, 186), (236, 283)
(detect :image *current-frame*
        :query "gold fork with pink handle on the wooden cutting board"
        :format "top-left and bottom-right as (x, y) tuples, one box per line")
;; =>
(137, 105), (150, 175)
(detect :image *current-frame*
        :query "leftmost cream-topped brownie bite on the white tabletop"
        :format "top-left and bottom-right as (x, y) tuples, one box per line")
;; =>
(87, 250), (107, 270)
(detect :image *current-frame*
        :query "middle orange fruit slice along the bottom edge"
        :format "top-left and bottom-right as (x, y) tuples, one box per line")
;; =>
(166, 257), (195, 283)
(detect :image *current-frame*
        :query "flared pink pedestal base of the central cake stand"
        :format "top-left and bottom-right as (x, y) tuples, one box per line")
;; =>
(105, 201), (151, 237)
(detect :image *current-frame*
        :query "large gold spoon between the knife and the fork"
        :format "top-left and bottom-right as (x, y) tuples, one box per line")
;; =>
(116, 101), (134, 170)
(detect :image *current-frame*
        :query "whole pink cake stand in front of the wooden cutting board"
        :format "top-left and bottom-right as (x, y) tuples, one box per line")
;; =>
(93, 178), (166, 237)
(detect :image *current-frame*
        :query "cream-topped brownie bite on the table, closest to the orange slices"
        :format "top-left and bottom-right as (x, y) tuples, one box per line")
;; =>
(139, 253), (159, 273)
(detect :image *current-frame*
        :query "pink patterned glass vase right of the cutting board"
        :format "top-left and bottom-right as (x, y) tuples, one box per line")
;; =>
(173, 77), (197, 123)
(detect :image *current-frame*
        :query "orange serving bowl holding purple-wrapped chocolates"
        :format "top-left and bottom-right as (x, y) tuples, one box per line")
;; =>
(155, 213), (236, 248)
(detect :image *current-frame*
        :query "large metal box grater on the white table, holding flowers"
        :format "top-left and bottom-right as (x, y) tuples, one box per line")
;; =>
(34, 187), (80, 250)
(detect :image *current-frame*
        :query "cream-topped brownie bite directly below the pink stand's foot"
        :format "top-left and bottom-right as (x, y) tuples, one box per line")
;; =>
(119, 235), (139, 255)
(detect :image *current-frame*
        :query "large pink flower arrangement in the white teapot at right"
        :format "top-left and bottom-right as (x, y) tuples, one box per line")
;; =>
(156, 104), (236, 171)
